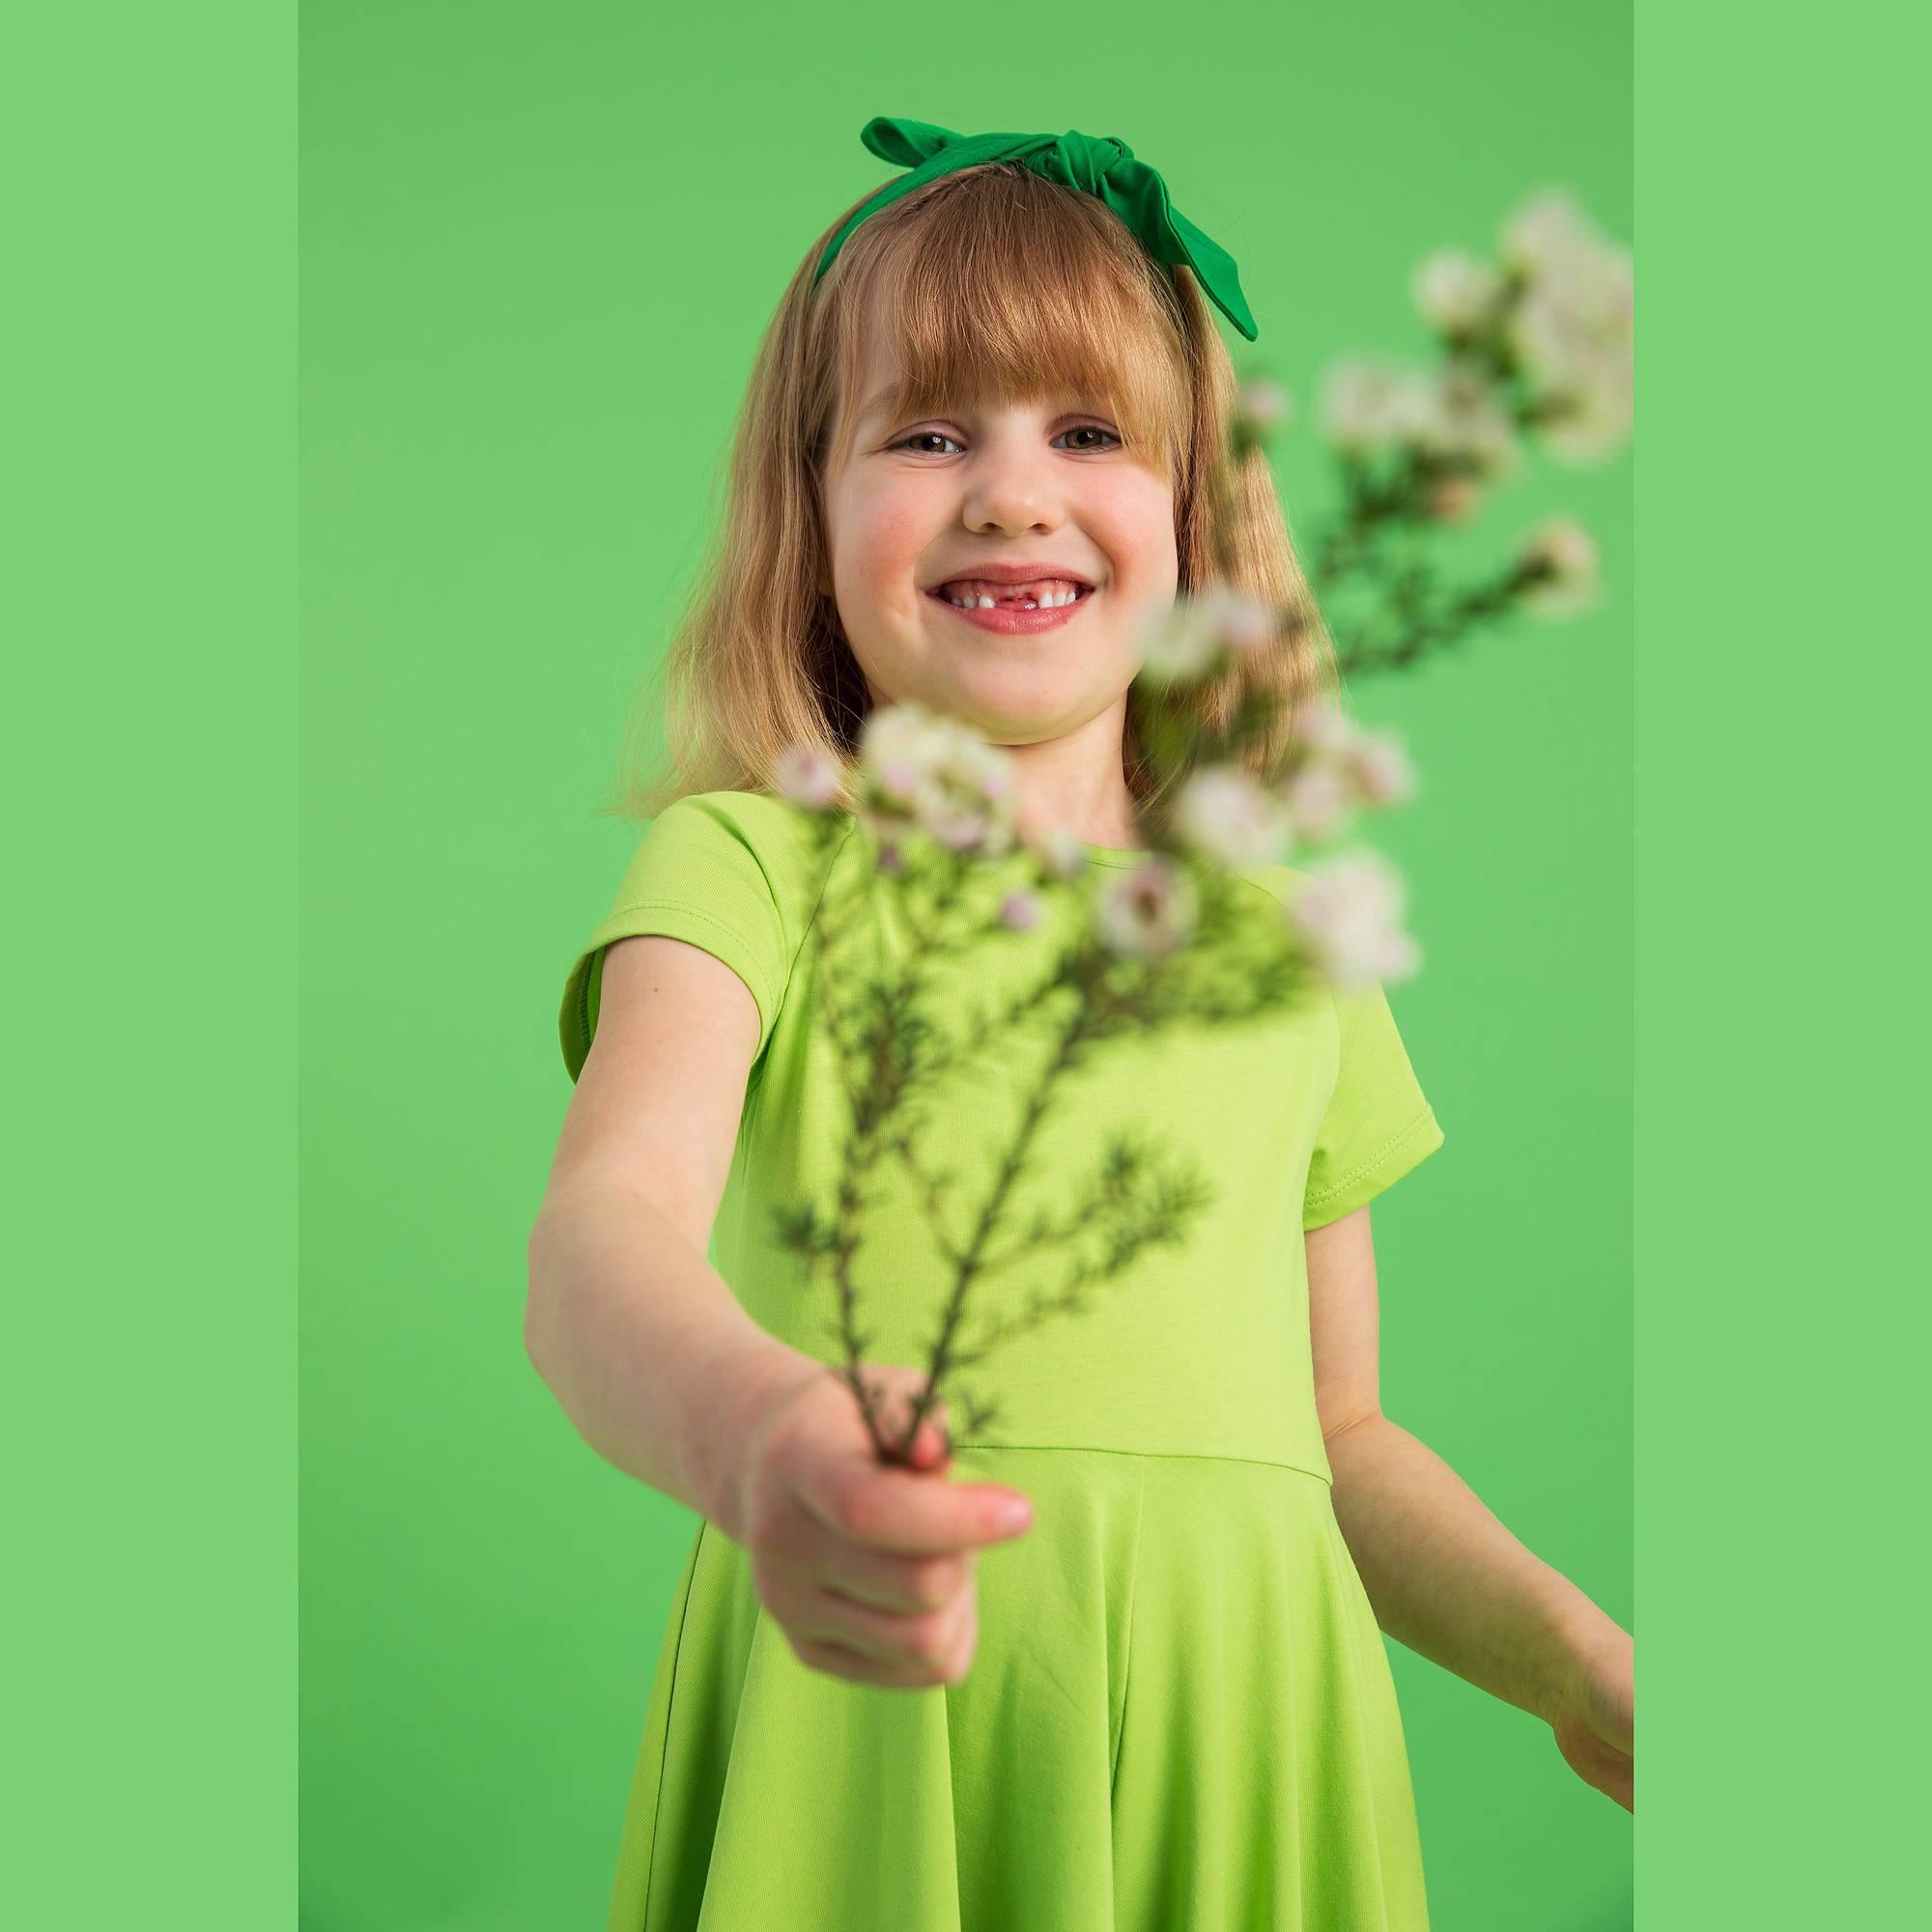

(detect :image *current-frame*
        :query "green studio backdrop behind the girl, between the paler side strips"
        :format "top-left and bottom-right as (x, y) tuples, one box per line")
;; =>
(299, 0), (1634, 1932)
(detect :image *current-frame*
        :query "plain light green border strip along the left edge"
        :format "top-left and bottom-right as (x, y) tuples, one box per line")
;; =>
(0, 0), (290, 1932)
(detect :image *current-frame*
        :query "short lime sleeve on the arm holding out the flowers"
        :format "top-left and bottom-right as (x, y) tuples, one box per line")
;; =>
(558, 792), (790, 1080)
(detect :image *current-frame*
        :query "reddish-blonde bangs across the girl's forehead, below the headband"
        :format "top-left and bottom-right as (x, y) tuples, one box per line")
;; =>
(821, 164), (1192, 483)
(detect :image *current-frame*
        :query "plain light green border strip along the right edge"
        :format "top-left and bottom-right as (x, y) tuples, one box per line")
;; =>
(1638, 0), (1932, 1932)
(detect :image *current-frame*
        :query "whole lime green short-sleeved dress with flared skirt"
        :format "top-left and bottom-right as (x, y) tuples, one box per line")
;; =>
(560, 792), (1443, 1932)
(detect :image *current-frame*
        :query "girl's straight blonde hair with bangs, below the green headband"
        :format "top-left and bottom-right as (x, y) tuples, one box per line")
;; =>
(597, 162), (1337, 819)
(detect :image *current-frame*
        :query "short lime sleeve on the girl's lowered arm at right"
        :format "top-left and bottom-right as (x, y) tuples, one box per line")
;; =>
(1302, 980), (1443, 1231)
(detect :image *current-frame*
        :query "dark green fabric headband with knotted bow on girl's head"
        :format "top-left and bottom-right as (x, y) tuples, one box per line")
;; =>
(811, 114), (1256, 342)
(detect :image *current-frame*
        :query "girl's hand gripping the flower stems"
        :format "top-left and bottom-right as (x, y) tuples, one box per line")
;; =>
(736, 1364), (1026, 1689)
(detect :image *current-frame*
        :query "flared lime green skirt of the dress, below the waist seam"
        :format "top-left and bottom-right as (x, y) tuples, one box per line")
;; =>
(609, 1443), (1428, 1932)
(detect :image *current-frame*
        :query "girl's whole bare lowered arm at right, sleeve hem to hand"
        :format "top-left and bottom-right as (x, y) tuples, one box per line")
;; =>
(1306, 1206), (1636, 1810)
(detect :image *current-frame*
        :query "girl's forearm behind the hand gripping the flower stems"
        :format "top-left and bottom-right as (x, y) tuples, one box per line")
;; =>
(524, 1186), (825, 1536)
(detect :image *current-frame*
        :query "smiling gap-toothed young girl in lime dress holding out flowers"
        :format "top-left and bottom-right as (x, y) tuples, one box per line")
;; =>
(527, 122), (1631, 1932)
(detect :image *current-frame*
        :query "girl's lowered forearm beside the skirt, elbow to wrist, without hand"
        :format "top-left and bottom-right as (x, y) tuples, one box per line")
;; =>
(1325, 1416), (1629, 1718)
